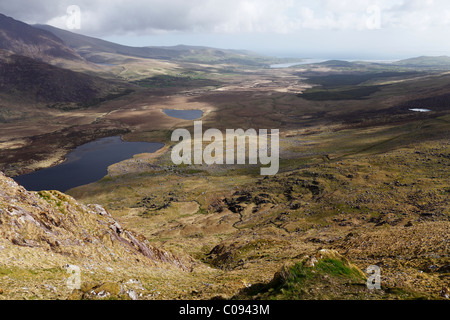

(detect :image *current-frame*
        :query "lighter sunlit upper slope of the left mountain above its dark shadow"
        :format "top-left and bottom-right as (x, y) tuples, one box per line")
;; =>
(0, 14), (83, 62)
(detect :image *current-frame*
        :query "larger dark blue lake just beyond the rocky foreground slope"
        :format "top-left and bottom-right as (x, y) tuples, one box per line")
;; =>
(14, 136), (164, 192)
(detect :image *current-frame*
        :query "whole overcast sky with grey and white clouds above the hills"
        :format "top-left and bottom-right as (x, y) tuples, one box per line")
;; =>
(0, 0), (450, 59)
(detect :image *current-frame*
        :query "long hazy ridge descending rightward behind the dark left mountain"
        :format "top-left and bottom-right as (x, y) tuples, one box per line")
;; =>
(34, 25), (268, 65)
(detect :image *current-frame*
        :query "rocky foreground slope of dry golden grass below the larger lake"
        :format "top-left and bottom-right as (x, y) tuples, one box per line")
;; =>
(0, 173), (190, 299)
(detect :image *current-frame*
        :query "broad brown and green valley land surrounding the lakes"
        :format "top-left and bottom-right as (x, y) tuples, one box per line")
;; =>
(0, 13), (450, 300)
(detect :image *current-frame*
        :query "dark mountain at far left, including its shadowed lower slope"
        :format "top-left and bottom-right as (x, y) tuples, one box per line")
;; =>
(0, 14), (134, 110)
